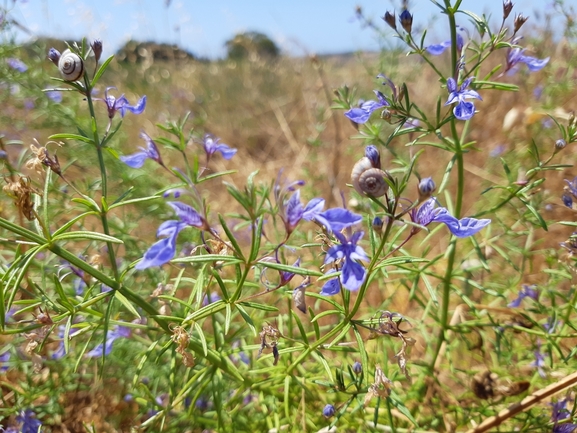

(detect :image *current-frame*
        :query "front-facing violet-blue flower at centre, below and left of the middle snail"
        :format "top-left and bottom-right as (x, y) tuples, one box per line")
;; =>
(321, 232), (369, 296)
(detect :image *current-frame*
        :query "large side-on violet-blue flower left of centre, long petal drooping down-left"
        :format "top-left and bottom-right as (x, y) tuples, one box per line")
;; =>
(134, 201), (209, 270)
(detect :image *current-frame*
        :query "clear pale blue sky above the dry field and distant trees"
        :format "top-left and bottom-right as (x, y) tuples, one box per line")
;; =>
(10, 0), (551, 58)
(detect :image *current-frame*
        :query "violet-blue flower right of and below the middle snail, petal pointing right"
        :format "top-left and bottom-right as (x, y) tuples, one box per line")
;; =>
(409, 197), (491, 238)
